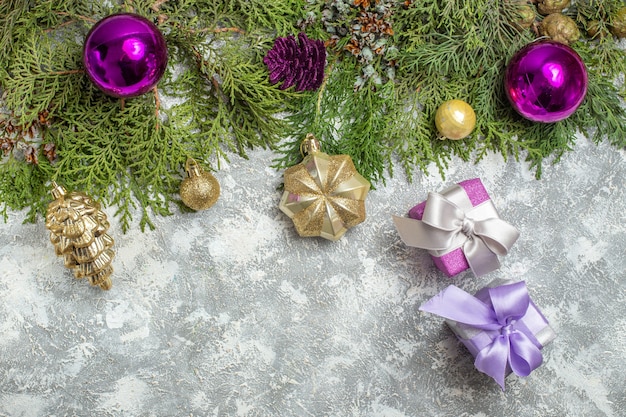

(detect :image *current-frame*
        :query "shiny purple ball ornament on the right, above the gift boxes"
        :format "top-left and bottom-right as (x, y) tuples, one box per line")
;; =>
(504, 40), (587, 123)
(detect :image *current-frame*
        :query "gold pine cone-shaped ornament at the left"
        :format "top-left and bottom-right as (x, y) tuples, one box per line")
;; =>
(46, 182), (115, 290)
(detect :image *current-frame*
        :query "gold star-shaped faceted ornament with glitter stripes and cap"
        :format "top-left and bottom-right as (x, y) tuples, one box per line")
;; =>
(278, 134), (370, 241)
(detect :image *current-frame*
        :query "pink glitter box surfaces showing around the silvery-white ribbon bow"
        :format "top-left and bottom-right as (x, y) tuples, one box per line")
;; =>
(409, 178), (508, 277)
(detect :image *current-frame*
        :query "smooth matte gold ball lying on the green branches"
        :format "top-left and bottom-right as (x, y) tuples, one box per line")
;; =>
(435, 100), (476, 140)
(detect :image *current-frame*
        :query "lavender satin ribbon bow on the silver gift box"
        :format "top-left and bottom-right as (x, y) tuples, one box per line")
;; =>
(419, 281), (543, 390)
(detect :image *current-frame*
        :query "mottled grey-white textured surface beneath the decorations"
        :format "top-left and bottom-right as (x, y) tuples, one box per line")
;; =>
(0, 137), (626, 417)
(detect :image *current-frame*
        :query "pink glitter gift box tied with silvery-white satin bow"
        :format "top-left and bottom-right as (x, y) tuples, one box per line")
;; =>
(394, 178), (519, 277)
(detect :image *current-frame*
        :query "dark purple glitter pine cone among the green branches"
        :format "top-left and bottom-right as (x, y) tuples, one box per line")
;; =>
(263, 33), (326, 91)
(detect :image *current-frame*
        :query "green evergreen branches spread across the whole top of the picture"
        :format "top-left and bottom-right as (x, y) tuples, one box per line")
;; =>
(0, 0), (626, 229)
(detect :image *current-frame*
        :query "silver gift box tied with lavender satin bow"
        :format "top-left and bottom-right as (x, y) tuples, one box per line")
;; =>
(420, 280), (556, 391)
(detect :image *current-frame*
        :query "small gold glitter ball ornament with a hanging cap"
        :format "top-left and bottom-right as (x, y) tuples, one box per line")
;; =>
(180, 158), (220, 210)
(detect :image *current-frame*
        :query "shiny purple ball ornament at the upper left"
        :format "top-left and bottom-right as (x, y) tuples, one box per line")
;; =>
(83, 13), (167, 98)
